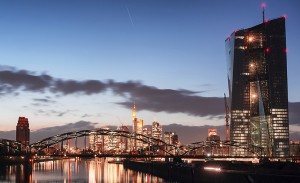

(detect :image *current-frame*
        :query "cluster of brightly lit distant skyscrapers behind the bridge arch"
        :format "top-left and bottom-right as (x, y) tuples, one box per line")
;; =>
(89, 104), (179, 152)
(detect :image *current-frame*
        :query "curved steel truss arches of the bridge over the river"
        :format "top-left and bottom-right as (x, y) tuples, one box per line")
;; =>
(0, 128), (264, 156)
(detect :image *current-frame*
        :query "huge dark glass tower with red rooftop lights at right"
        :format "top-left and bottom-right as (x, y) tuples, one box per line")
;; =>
(225, 17), (289, 157)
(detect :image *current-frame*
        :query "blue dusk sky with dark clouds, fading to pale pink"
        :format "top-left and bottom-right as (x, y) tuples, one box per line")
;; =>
(0, 0), (300, 136)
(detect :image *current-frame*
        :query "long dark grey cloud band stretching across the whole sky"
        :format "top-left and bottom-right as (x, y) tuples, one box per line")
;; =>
(0, 66), (300, 118)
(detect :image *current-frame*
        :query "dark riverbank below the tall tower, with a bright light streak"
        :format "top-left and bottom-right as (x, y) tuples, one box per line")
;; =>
(124, 160), (300, 183)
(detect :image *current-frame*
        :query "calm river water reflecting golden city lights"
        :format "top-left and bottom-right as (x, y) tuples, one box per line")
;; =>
(0, 158), (166, 183)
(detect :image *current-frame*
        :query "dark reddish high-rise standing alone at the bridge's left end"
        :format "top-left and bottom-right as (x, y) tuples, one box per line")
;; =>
(16, 117), (30, 146)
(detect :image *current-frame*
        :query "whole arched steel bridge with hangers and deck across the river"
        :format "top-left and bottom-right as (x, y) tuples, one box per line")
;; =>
(0, 128), (264, 157)
